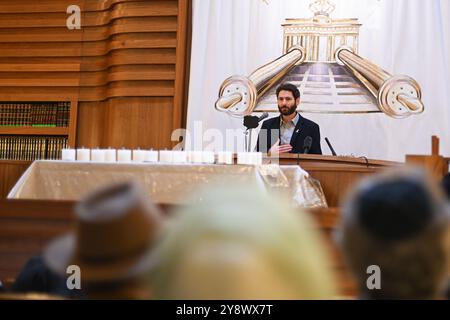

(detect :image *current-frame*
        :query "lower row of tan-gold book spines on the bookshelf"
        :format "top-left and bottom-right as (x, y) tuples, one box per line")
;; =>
(0, 136), (68, 161)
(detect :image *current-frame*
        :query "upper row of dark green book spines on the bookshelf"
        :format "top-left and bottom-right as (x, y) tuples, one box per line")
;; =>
(0, 102), (70, 127)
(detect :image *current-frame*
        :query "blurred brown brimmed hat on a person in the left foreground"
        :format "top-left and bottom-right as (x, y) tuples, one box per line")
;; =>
(44, 182), (163, 283)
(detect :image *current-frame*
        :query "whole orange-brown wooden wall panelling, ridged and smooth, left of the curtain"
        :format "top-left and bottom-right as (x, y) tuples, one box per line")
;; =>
(0, 0), (191, 192)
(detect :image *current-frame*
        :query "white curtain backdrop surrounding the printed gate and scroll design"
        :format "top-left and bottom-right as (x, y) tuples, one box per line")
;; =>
(186, 0), (450, 161)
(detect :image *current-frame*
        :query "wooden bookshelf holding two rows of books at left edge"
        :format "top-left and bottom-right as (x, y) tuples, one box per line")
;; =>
(0, 98), (78, 161)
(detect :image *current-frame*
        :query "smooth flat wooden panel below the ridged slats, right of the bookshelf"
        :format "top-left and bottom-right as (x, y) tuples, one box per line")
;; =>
(77, 97), (173, 148)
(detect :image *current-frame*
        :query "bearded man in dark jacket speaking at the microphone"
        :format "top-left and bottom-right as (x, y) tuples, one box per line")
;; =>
(256, 83), (322, 154)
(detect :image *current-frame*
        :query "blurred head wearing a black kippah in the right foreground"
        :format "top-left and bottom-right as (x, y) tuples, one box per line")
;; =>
(336, 168), (450, 299)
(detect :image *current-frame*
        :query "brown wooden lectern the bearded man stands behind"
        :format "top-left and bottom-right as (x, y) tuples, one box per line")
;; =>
(265, 154), (403, 207)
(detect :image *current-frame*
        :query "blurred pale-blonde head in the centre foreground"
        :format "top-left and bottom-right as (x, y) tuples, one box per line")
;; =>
(149, 185), (334, 299)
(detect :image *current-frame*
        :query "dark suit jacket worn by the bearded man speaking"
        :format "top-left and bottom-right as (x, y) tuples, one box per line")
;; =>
(256, 114), (322, 154)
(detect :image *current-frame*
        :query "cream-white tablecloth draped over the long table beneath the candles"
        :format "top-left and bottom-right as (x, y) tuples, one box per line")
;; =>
(8, 160), (326, 207)
